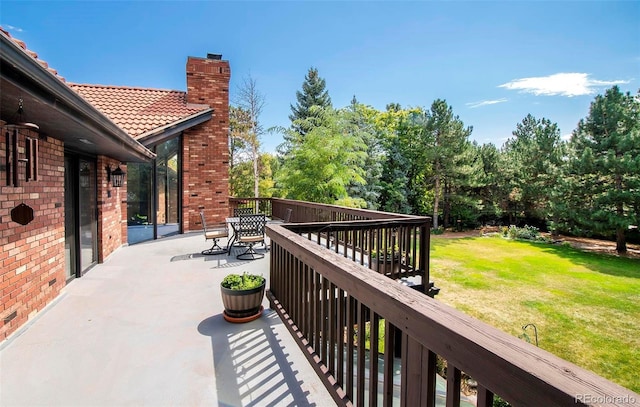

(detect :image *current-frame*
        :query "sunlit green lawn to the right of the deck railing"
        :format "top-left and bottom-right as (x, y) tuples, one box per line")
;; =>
(431, 237), (640, 393)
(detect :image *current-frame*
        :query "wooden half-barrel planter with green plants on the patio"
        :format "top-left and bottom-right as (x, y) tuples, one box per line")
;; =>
(220, 275), (266, 323)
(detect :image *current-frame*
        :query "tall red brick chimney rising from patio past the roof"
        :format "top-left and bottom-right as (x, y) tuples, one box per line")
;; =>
(183, 54), (231, 232)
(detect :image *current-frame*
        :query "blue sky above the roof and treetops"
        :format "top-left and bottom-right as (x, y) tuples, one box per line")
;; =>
(0, 0), (640, 151)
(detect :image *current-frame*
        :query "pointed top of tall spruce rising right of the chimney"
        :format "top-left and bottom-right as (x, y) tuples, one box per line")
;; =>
(289, 67), (331, 136)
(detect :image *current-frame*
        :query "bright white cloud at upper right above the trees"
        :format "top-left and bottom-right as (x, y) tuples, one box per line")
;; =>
(498, 72), (629, 97)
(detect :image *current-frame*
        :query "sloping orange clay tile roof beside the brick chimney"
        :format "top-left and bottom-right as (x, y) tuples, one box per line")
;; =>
(69, 83), (209, 138)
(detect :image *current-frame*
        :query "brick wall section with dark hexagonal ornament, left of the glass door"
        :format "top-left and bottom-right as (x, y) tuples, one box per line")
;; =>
(0, 134), (65, 341)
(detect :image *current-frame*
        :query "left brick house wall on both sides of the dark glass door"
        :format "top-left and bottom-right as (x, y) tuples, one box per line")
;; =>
(0, 133), (127, 341)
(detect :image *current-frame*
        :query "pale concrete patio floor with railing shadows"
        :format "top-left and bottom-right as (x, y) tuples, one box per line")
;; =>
(0, 233), (335, 406)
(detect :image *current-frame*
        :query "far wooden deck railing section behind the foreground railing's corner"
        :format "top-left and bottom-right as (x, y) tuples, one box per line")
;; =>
(229, 198), (439, 296)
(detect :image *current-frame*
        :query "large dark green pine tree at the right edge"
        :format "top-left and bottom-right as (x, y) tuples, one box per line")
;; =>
(565, 86), (640, 253)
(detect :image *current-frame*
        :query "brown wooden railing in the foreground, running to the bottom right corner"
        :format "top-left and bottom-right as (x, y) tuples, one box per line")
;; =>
(267, 223), (640, 407)
